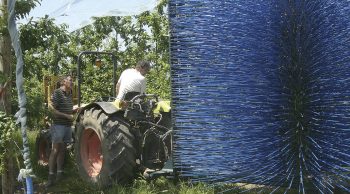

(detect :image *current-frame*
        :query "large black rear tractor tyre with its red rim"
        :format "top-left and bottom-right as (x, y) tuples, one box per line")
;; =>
(75, 107), (136, 187)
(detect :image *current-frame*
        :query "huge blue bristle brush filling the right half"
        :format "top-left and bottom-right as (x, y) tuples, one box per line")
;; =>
(169, 0), (350, 193)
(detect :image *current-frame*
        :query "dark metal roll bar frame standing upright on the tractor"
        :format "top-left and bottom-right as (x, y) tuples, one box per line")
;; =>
(77, 51), (117, 107)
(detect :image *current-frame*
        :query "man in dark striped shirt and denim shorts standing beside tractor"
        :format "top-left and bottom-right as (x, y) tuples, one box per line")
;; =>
(46, 76), (73, 187)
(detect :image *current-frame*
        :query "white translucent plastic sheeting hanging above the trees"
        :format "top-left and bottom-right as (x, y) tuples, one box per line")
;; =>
(20, 0), (157, 32)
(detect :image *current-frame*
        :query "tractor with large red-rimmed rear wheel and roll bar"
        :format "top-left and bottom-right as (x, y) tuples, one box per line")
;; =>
(37, 51), (172, 187)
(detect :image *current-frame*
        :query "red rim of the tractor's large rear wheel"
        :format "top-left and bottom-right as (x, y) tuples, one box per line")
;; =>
(80, 128), (103, 177)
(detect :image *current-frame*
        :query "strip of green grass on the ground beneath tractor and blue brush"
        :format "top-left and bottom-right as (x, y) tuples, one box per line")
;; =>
(11, 131), (300, 194)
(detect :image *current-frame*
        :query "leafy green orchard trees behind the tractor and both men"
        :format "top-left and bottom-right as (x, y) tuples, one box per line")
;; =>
(12, 0), (171, 129)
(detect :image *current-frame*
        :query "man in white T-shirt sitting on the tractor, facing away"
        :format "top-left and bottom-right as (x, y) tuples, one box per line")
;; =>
(116, 61), (151, 100)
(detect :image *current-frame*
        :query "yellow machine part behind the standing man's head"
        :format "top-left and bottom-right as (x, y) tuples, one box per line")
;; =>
(43, 75), (78, 104)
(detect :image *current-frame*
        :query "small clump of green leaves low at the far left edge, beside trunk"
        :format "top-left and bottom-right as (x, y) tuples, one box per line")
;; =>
(0, 111), (16, 174)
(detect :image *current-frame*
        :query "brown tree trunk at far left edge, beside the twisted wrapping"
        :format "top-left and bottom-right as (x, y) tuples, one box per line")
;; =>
(0, 0), (15, 194)
